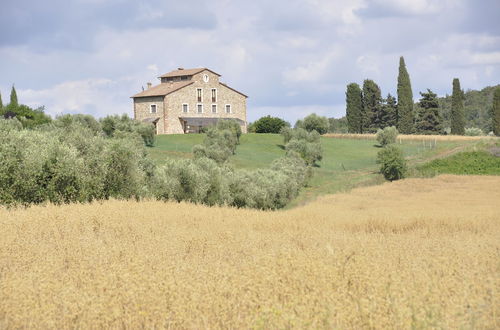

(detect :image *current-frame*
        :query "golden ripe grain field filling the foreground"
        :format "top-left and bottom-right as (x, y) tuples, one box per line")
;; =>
(0, 176), (500, 329)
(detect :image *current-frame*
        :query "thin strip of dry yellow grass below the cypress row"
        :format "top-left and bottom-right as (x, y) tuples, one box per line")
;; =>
(323, 133), (500, 142)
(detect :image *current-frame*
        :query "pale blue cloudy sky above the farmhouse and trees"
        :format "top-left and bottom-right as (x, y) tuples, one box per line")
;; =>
(0, 0), (500, 124)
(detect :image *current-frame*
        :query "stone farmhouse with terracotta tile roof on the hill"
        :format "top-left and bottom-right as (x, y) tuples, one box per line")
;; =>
(132, 68), (247, 134)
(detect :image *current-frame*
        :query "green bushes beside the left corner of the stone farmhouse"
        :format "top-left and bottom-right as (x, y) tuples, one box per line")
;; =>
(99, 114), (155, 147)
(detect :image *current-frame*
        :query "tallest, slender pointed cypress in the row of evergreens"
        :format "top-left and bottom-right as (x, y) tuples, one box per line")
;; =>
(397, 56), (415, 134)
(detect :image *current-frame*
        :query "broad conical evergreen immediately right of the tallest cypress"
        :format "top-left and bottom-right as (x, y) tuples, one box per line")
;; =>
(415, 89), (443, 134)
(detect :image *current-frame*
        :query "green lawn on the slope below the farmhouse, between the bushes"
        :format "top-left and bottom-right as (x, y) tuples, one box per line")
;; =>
(149, 134), (470, 207)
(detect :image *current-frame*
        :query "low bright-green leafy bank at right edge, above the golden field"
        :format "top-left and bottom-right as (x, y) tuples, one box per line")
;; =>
(418, 151), (500, 175)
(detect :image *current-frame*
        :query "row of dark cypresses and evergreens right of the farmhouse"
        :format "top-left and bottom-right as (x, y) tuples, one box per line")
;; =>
(346, 56), (500, 135)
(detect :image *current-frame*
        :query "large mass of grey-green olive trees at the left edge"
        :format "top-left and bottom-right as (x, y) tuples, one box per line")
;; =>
(0, 122), (151, 205)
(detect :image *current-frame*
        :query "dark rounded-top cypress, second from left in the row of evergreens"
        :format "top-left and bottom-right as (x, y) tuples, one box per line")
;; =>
(363, 79), (382, 133)
